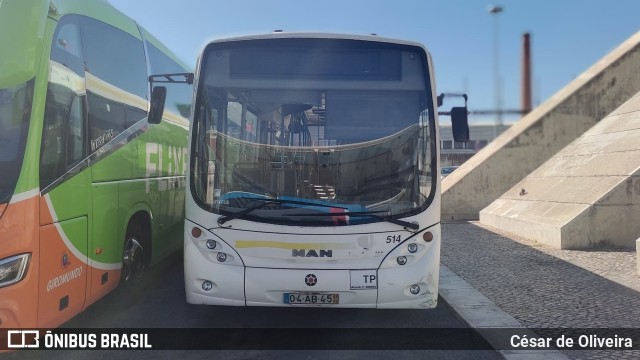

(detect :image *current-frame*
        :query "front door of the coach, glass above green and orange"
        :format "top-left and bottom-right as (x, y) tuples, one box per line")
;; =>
(38, 16), (91, 327)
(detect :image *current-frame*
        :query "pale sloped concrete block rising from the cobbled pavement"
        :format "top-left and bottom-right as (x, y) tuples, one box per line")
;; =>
(480, 92), (640, 249)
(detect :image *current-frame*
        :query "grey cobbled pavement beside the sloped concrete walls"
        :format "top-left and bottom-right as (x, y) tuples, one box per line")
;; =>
(441, 222), (640, 359)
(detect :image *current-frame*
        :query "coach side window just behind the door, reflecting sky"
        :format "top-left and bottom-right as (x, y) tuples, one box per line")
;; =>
(82, 18), (148, 152)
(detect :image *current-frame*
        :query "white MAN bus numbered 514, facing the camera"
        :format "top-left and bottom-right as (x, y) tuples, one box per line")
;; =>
(153, 33), (468, 308)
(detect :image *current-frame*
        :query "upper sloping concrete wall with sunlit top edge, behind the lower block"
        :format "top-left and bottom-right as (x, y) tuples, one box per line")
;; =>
(442, 32), (640, 220)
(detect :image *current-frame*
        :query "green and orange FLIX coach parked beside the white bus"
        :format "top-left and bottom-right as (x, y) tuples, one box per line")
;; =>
(0, 0), (192, 328)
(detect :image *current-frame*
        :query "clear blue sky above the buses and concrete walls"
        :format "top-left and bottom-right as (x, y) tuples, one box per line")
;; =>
(108, 0), (640, 122)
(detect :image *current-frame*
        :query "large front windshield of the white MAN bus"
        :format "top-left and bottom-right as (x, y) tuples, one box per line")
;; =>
(191, 38), (435, 226)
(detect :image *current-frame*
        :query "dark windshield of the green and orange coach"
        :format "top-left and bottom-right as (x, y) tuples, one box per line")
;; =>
(0, 80), (33, 204)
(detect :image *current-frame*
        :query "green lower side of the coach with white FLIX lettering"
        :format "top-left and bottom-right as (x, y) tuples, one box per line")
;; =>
(40, 123), (187, 264)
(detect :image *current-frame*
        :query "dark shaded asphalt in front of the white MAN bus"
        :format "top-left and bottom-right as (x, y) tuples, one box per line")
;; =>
(7, 254), (500, 360)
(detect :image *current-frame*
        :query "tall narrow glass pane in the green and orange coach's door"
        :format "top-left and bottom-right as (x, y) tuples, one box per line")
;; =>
(40, 16), (87, 189)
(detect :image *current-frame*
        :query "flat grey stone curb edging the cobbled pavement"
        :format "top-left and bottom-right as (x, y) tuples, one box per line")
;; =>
(438, 264), (569, 360)
